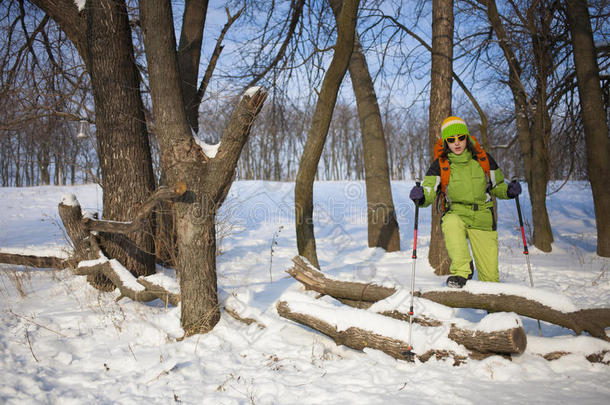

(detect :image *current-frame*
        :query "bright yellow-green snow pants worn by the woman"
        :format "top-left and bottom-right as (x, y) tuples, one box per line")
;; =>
(441, 212), (500, 282)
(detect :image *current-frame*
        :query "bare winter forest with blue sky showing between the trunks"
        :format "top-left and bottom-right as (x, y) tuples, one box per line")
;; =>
(0, 0), (610, 337)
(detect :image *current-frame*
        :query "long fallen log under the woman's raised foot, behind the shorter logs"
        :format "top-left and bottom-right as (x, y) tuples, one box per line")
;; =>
(287, 256), (610, 341)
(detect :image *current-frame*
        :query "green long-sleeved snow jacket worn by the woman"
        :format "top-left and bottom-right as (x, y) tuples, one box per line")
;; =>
(422, 150), (508, 231)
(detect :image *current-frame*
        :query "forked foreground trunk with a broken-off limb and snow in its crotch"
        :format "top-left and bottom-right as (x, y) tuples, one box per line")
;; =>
(140, 0), (266, 336)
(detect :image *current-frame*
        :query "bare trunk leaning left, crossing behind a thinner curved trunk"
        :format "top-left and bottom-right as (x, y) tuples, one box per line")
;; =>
(330, 0), (400, 252)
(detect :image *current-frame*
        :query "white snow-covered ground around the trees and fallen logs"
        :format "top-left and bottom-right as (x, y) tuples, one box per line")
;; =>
(0, 181), (610, 404)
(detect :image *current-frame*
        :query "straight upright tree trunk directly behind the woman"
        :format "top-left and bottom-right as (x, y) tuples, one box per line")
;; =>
(428, 0), (453, 275)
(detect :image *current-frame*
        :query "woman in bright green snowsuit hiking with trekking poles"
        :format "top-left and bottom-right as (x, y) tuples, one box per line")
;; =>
(409, 117), (521, 288)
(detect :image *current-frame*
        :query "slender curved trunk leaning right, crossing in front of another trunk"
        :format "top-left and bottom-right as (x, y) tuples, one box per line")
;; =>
(294, 0), (360, 267)
